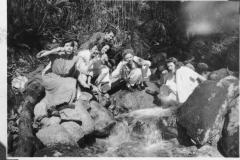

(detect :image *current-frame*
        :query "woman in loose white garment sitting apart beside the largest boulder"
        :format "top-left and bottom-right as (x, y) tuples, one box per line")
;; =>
(146, 57), (206, 108)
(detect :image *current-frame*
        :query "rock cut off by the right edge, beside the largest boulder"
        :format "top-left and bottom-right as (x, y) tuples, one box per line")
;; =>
(220, 92), (239, 157)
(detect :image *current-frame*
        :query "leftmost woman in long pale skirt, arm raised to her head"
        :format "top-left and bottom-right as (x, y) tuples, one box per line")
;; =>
(35, 35), (78, 113)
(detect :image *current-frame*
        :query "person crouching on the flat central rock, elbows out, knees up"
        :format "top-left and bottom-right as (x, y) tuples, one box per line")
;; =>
(112, 49), (151, 92)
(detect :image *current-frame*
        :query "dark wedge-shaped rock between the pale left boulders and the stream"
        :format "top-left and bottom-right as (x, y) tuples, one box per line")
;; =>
(90, 101), (115, 132)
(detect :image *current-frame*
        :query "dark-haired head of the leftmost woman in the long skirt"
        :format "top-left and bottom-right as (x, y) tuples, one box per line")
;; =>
(60, 35), (78, 54)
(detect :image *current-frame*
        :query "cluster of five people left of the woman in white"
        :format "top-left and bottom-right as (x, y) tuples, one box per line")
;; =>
(37, 30), (151, 111)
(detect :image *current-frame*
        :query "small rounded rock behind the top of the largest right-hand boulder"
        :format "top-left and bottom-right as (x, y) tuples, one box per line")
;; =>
(208, 68), (233, 81)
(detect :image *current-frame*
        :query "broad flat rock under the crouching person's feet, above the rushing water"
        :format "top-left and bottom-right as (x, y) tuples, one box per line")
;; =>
(112, 82), (160, 110)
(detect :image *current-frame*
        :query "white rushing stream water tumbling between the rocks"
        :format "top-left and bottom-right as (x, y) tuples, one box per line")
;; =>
(96, 108), (186, 157)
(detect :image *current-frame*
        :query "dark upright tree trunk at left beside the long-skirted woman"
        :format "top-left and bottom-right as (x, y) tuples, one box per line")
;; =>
(14, 65), (44, 157)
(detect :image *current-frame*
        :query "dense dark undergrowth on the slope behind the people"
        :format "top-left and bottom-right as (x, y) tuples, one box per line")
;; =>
(7, 0), (239, 112)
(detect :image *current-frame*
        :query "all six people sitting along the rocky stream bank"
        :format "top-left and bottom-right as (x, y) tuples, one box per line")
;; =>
(37, 27), (205, 114)
